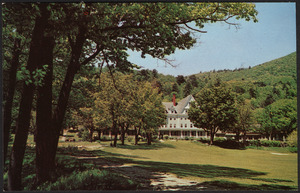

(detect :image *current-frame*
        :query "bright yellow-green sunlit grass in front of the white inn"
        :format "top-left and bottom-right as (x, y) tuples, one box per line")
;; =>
(96, 141), (298, 186)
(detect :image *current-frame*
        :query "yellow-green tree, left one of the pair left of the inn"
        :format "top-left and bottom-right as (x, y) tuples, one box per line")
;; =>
(93, 73), (134, 147)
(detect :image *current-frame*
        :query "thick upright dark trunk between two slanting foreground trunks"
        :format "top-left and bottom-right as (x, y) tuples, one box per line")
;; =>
(36, 37), (55, 185)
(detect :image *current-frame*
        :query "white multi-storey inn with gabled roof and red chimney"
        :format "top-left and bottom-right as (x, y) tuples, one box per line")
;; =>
(159, 95), (207, 138)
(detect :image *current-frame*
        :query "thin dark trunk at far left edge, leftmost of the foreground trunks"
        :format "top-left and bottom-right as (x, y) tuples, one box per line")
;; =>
(3, 38), (21, 163)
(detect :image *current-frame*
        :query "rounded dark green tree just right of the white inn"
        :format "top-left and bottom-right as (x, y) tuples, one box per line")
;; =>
(188, 84), (237, 145)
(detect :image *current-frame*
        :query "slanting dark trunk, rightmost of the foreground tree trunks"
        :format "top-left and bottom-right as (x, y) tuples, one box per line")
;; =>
(48, 24), (87, 164)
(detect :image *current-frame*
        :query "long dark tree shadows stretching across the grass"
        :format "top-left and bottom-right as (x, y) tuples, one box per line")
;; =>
(54, 146), (297, 190)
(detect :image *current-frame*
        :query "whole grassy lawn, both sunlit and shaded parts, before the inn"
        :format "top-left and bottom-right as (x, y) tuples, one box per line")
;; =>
(4, 136), (298, 190)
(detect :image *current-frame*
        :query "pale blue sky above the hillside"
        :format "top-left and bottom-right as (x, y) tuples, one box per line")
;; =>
(128, 2), (296, 76)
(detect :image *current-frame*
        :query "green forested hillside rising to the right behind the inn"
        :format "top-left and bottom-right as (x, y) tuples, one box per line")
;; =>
(154, 52), (297, 108)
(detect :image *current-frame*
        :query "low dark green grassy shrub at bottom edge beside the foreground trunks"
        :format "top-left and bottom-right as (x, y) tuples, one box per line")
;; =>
(38, 169), (137, 191)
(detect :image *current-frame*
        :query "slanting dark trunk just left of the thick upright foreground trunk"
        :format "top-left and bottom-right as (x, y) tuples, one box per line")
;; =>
(8, 3), (50, 191)
